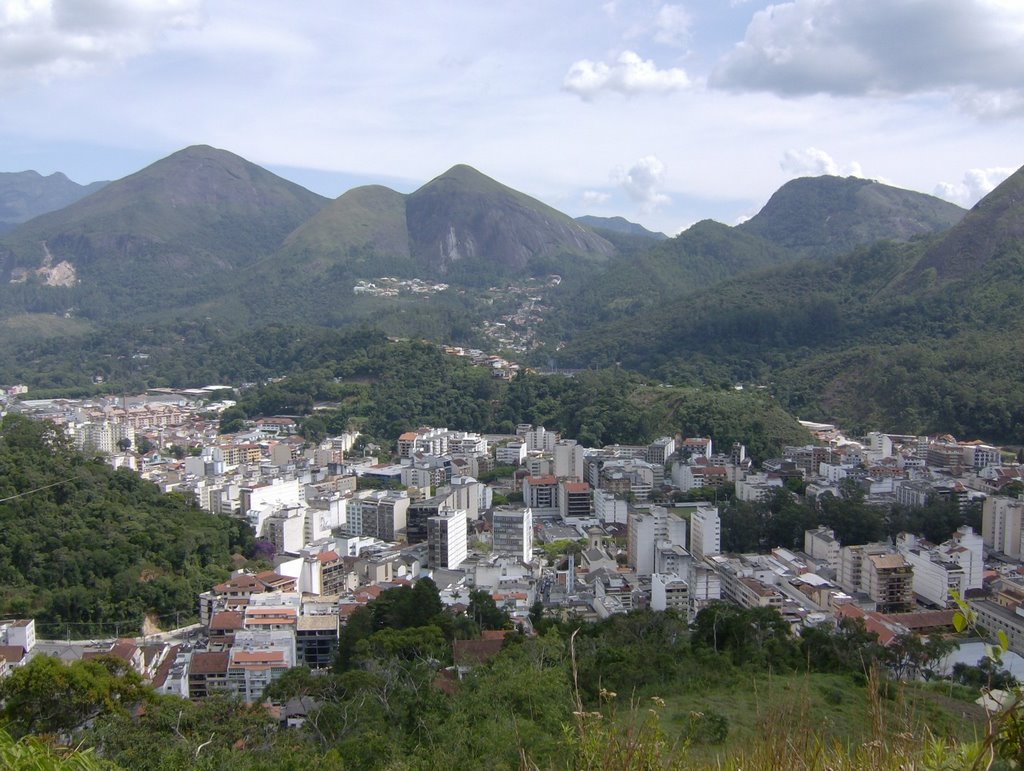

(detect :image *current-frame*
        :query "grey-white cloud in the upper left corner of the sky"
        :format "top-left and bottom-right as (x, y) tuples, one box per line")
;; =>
(0, 0), (203, 79)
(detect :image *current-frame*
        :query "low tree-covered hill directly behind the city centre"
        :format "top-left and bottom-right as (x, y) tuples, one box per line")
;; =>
(221, 335), (810, 458)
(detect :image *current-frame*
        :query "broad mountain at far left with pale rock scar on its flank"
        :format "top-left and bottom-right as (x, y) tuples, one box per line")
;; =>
(0, 146), (327, 320)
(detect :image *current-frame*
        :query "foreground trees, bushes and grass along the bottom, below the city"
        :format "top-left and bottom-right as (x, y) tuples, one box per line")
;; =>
(0, 606), (999, 769)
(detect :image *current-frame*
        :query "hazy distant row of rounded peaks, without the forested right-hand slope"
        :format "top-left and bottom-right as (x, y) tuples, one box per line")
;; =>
(0, 145), (962, 319)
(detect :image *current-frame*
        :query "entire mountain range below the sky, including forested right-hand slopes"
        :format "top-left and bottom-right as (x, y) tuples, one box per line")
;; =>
(0, 146), (1024, 440)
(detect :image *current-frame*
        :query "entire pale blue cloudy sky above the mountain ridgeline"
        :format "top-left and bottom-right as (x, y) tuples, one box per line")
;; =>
(0, 0), (1024, 233)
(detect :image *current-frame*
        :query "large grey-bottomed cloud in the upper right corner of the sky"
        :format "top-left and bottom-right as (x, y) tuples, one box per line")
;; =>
(709, 0), (1024, 111)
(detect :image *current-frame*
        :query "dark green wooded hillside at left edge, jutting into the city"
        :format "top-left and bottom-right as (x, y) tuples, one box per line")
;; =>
(0, 415), (252, 638)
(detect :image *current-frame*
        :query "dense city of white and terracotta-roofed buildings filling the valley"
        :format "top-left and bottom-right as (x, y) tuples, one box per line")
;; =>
(0, 372), (1024, 709)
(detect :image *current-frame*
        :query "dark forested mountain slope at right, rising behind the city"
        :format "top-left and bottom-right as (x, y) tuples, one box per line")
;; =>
(559, 220), (1024, 442)
